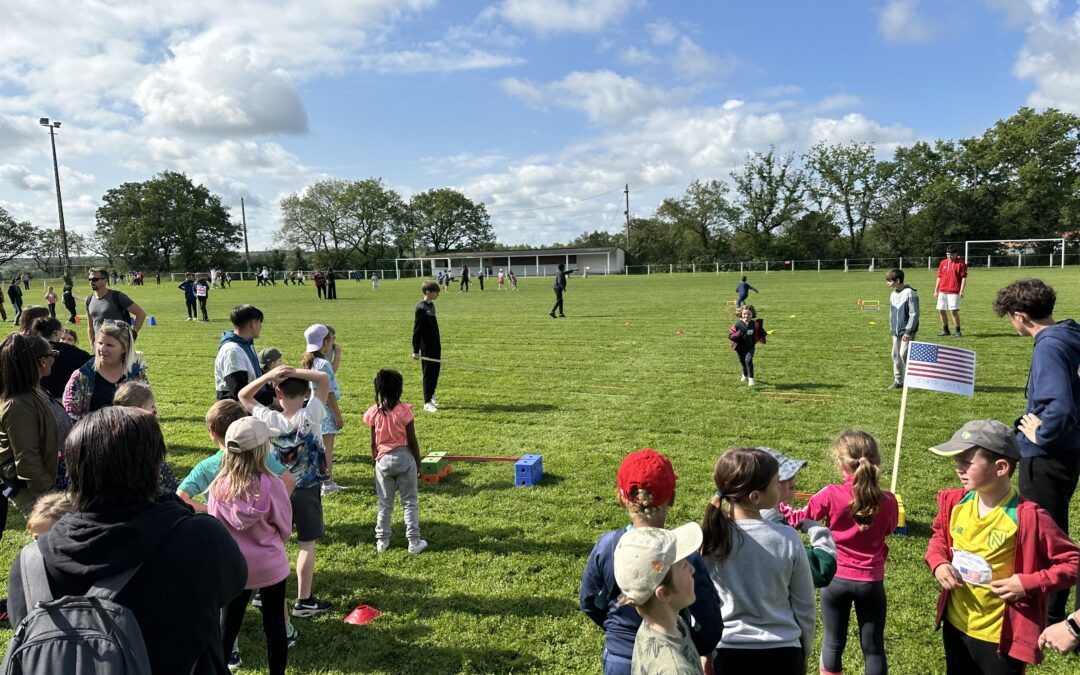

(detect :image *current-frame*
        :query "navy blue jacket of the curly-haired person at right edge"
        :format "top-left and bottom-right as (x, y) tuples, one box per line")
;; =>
(1016, 319), (1080, 457)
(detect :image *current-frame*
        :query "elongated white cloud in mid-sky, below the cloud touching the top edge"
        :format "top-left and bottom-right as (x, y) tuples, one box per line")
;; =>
(499, 70), (683, 122)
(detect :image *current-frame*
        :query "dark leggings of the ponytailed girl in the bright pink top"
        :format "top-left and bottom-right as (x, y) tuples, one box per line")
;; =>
(821, 578), (889, 675)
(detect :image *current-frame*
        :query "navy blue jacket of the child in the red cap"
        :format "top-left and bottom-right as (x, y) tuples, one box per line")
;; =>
(580, 528), (724, 659)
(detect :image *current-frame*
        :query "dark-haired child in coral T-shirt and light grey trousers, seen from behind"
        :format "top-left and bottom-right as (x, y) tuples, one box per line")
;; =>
(364, 368), (428, 554)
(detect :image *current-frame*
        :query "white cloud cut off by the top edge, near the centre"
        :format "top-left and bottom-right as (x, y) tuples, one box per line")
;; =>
(494, 0), (642, 35)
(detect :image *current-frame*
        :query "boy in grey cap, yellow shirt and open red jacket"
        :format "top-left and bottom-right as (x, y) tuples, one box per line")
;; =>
(926, 419), (1080, 674)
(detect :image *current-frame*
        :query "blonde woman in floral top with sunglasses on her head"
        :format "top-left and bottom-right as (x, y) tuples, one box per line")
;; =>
(64, 321), (147, 421)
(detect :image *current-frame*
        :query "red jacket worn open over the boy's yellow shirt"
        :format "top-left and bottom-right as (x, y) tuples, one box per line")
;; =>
(926, 488), (1080, 663)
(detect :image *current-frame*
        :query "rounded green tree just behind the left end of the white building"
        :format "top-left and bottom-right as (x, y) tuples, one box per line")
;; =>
(409, 188), (495, 252)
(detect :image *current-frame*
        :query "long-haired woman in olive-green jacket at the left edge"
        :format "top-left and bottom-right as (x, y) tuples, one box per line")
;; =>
(0, 333), (67, 516)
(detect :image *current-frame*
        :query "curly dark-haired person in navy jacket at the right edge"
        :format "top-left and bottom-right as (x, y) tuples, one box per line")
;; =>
(994, 279), (1080, 623)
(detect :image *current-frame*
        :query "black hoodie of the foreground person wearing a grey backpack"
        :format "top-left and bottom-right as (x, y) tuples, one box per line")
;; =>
(8, 495), (247, 675)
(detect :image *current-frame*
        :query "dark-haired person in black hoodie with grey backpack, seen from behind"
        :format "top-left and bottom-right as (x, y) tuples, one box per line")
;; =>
(8, 407), (247, 675)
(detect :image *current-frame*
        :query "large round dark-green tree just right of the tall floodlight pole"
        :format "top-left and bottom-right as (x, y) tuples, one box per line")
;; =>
(97, 171), (243, 270)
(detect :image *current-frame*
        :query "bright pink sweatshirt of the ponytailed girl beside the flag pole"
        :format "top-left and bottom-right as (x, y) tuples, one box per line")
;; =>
(785, 476), (900, 581)
